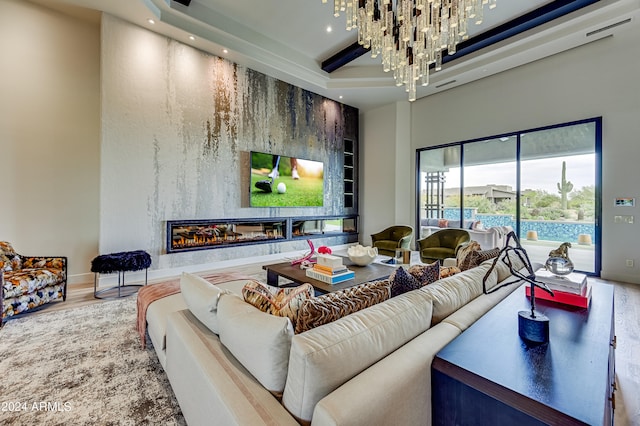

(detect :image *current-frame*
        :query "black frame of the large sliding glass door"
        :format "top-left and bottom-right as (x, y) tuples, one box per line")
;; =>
(415, 117), (602, 276)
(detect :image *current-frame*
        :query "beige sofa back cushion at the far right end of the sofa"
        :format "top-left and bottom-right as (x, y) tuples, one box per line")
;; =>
(418, 261), (498, 325)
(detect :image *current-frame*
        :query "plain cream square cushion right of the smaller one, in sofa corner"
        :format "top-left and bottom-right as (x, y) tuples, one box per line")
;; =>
(218, 294), (293, 395)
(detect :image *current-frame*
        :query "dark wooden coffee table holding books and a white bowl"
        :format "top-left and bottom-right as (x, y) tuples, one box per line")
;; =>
(262, 258), (397, 293)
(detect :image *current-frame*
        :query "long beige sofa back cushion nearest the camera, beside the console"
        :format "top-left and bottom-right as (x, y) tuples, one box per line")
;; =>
(282, 290), (431, 422)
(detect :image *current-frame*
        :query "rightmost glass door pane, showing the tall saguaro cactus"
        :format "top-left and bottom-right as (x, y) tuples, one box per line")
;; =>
(520, 122), (596, 272)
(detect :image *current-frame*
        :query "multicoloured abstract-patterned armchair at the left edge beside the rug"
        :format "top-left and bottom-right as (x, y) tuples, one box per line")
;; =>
(0, 241), (67, 326)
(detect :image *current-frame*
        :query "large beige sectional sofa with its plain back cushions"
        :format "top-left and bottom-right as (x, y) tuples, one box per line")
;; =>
(146, 253), (524, 426)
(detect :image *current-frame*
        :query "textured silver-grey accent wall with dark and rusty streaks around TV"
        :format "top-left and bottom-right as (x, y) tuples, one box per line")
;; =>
(100, 15), (358, 269)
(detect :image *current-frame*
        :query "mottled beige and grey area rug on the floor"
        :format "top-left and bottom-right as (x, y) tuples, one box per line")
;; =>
(0, 296), (186, 426)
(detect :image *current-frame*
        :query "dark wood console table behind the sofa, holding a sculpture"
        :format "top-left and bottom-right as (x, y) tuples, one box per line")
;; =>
(432, 282), (615, 426)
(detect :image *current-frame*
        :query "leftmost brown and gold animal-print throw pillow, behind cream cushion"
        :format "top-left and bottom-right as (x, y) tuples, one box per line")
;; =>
(242, 281), (314, 329)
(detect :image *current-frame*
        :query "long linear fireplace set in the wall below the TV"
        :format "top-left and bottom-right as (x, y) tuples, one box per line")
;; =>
(167, 216), (358, 253)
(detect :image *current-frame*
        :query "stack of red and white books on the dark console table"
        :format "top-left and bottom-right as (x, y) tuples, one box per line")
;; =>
(526, 269), (591, 308)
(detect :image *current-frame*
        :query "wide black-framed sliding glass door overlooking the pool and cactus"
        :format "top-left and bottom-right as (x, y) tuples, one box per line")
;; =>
(416, 118), (602, 275)
